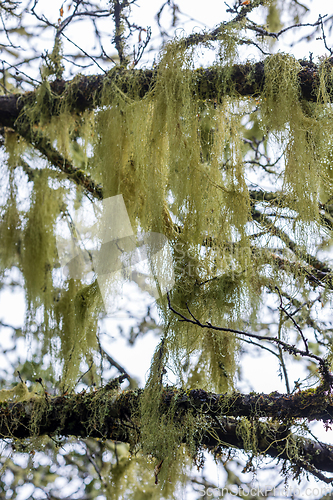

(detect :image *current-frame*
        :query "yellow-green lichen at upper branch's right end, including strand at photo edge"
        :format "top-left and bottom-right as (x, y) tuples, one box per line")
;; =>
(261, 53), (332, 229)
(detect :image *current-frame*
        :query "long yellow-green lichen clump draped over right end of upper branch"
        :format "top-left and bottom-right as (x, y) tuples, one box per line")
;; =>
(261, 53), (323, 226)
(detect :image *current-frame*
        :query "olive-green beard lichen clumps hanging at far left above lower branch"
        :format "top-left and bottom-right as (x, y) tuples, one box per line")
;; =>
(20, 170), (101, 390)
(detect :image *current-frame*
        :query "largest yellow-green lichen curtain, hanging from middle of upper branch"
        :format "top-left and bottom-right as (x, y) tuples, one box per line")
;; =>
(91, 35), (260, 390)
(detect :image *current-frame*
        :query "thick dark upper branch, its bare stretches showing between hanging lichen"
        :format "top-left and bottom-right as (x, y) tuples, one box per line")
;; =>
(0, 60), (326, 129)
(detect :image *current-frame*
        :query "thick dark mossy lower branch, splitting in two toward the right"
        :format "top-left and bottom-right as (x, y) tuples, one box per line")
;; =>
(0, 387), (333, 472)
